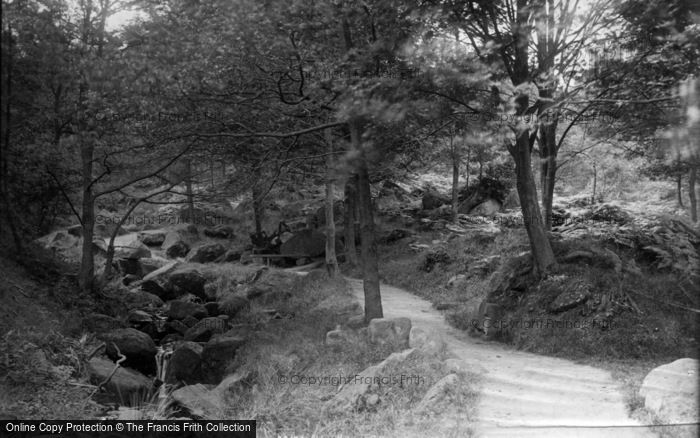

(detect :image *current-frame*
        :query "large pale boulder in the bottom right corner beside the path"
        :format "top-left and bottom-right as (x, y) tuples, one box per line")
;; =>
(639, 359), (700, 438)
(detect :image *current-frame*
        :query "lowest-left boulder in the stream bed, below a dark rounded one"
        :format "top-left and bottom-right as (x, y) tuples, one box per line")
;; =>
(87, 357), (153, 403)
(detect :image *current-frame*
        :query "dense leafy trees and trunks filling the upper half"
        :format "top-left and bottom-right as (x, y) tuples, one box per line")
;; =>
(0, 0), (700, 298)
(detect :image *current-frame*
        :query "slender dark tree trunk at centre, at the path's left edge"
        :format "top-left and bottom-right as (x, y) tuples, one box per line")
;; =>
(350, 122), (384, 322)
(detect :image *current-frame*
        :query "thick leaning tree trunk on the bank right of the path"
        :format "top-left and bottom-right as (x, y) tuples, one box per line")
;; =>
(513, 130), (556, 276)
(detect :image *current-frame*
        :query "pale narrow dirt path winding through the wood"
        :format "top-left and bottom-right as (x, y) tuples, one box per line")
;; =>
(349, 279), (656, 438)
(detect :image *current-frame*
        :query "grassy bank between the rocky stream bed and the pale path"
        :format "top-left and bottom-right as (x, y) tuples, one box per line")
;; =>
(221, 271), (476, 436)
